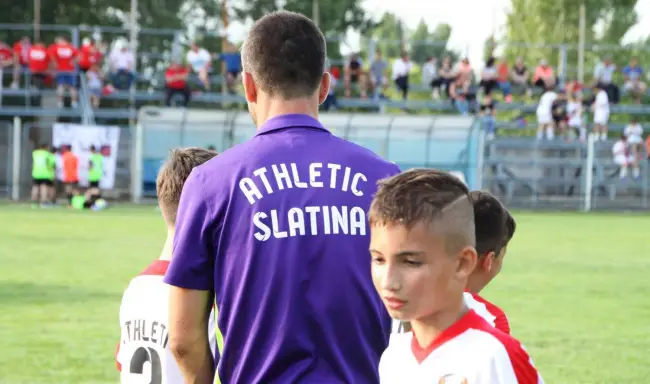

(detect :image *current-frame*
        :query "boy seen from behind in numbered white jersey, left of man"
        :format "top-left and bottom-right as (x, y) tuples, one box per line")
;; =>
(117, 148), (217, 384)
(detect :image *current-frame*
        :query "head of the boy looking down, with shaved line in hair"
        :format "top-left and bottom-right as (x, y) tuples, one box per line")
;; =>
(369, 169), (477, 321)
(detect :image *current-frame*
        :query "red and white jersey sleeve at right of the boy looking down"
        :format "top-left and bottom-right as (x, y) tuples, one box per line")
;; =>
(477, 338), (544, 384)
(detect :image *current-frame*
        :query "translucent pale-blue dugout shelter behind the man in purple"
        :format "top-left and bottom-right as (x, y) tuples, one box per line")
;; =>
(131, 107), (481, 201)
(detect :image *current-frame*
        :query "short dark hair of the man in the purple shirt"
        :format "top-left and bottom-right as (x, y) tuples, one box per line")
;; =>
(242, 11), (327, 100)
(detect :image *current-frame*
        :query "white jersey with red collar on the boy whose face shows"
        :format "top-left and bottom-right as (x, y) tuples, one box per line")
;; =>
(379, 310), (544, 384)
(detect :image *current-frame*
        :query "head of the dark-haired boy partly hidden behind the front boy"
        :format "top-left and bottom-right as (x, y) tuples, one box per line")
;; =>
(467, 191), (515, 293)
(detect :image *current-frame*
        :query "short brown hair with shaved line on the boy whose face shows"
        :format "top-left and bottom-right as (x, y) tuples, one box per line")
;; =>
(368, 169), (475, 253)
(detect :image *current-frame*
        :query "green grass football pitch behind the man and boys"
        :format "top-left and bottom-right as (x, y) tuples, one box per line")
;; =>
(0, 205), (650, 384)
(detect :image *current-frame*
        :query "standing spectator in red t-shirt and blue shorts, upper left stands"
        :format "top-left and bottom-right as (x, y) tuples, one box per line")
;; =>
(48, 36), (79, 108)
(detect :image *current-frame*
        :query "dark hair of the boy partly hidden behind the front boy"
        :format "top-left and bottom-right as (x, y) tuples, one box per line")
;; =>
(470, 191), (516, 257)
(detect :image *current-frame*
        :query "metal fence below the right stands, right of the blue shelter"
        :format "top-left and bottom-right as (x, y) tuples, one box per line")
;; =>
(481, 137), (650, 211)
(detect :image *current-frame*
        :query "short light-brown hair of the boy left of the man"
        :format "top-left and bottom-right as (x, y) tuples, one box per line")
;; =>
(156, 147), (217, 224)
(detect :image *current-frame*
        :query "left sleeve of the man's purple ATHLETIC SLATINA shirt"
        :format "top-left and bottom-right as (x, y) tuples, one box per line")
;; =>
(165, 170), (215, 291)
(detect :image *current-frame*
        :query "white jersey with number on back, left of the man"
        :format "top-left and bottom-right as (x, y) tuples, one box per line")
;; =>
(116, 260), (216, 384)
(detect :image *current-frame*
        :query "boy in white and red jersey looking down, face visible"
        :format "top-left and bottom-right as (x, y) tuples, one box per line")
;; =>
(369, 169), (543, 384)
